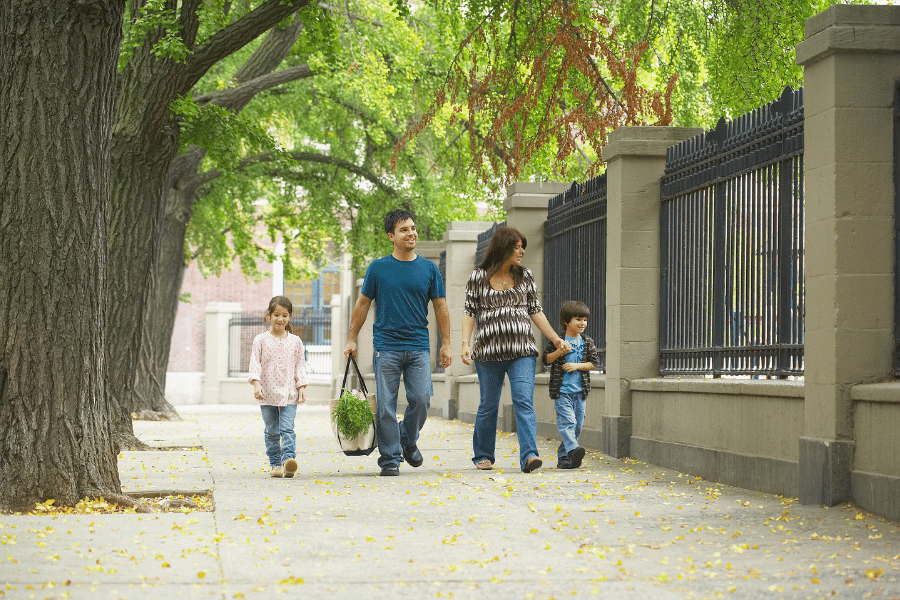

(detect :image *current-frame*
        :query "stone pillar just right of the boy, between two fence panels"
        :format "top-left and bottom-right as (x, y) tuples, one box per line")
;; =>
(601, 127), (703, 458)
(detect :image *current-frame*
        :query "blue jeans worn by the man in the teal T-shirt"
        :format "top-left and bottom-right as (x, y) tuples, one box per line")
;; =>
(374, 350), (433, 467)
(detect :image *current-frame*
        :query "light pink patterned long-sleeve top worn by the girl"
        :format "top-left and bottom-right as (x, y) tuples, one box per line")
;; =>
(249, 331), (308, 406)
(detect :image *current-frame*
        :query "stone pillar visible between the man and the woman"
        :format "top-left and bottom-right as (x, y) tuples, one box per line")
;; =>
(435, 221), (493, 419)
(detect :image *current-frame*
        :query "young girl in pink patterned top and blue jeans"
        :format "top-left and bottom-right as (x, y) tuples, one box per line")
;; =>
(249, 296), (307, 477)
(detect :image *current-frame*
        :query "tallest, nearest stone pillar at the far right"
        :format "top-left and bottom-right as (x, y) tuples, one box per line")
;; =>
(797, 5), (900, 506)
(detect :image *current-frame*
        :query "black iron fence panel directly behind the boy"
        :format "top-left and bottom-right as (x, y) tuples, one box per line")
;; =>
(543, 174), (606, 371)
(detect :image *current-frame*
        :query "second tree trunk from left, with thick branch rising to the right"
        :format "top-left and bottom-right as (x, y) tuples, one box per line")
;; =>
(108, 0), (310, 432)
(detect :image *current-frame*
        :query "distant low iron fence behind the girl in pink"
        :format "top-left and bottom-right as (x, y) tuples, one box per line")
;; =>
(228, 308), (331, 381)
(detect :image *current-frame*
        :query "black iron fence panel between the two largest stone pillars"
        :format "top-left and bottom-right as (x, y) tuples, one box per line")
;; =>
(660, 88), (805, 376)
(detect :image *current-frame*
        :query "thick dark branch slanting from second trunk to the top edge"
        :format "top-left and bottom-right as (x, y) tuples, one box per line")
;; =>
(180, 0), (312, 93)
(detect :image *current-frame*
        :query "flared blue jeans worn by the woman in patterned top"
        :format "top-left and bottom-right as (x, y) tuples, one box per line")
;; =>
(472, 356), (538, 468)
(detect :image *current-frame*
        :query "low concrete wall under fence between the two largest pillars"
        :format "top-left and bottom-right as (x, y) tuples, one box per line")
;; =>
(630, 378), (803, 497)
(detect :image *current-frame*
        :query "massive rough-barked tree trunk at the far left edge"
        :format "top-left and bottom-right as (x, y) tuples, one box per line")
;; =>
(0, 0), (124, 508)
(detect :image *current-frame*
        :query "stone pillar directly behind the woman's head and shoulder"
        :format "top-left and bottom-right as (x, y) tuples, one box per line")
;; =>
(503, 181), (572, 352)
